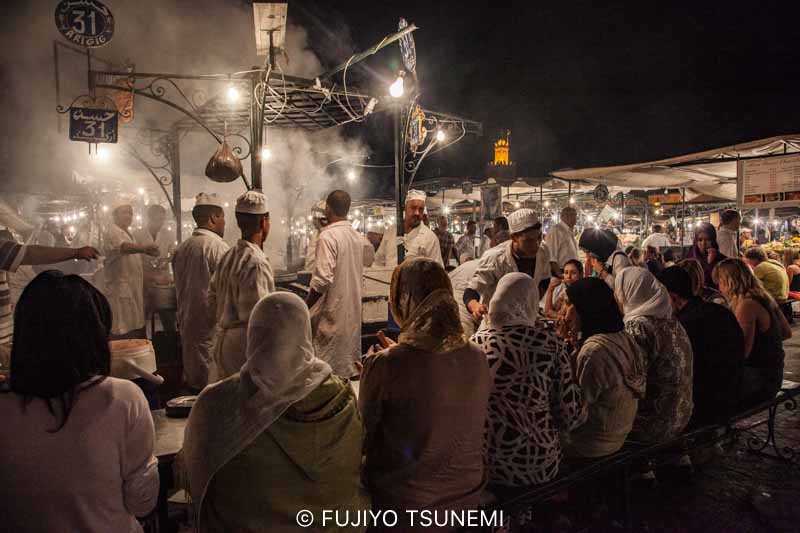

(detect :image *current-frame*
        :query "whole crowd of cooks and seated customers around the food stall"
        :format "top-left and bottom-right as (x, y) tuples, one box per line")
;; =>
(0, 190), (800, 531)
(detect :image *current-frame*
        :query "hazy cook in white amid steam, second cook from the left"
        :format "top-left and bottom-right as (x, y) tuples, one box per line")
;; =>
(133, 204), (175, 331)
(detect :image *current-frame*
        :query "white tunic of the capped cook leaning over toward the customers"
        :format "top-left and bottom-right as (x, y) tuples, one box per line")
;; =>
(468, 240), (551, 323)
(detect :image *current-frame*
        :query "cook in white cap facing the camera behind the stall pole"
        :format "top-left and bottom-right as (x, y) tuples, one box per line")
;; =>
(373, 189), (444, 267)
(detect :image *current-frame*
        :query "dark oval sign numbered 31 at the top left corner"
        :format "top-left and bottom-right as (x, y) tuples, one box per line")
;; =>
(56, 0), (114, 48)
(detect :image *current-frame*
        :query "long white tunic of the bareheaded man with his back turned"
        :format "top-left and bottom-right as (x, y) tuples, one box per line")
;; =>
(310, 220), (364, 378)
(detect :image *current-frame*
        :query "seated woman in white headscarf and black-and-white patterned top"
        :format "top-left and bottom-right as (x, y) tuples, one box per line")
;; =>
(472, 272), (586, 497)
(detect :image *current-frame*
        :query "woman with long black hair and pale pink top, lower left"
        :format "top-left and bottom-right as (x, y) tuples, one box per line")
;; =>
(0, 271), (158, 533)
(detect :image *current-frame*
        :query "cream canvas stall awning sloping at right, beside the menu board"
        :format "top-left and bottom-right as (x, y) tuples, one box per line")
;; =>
(551, 134), (800, 201)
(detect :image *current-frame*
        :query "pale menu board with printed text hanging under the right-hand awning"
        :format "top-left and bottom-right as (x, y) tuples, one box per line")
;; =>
(737, 154), (800, 208)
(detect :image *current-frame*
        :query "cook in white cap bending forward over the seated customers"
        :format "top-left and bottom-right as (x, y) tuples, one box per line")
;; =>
(464, 209), (551, 320)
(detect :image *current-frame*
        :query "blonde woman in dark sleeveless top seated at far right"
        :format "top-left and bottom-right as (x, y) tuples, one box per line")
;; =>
(713, 259), (792, 408)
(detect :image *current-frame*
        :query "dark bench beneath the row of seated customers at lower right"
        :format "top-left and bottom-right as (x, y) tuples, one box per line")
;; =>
(476, 380), (800, 533)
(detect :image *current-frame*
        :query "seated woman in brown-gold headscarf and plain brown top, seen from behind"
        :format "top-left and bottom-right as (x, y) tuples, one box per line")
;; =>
(358, 258), (491, 532)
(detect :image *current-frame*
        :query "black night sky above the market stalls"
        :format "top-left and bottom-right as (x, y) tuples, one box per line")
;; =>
(296, 1), (800, 179)
